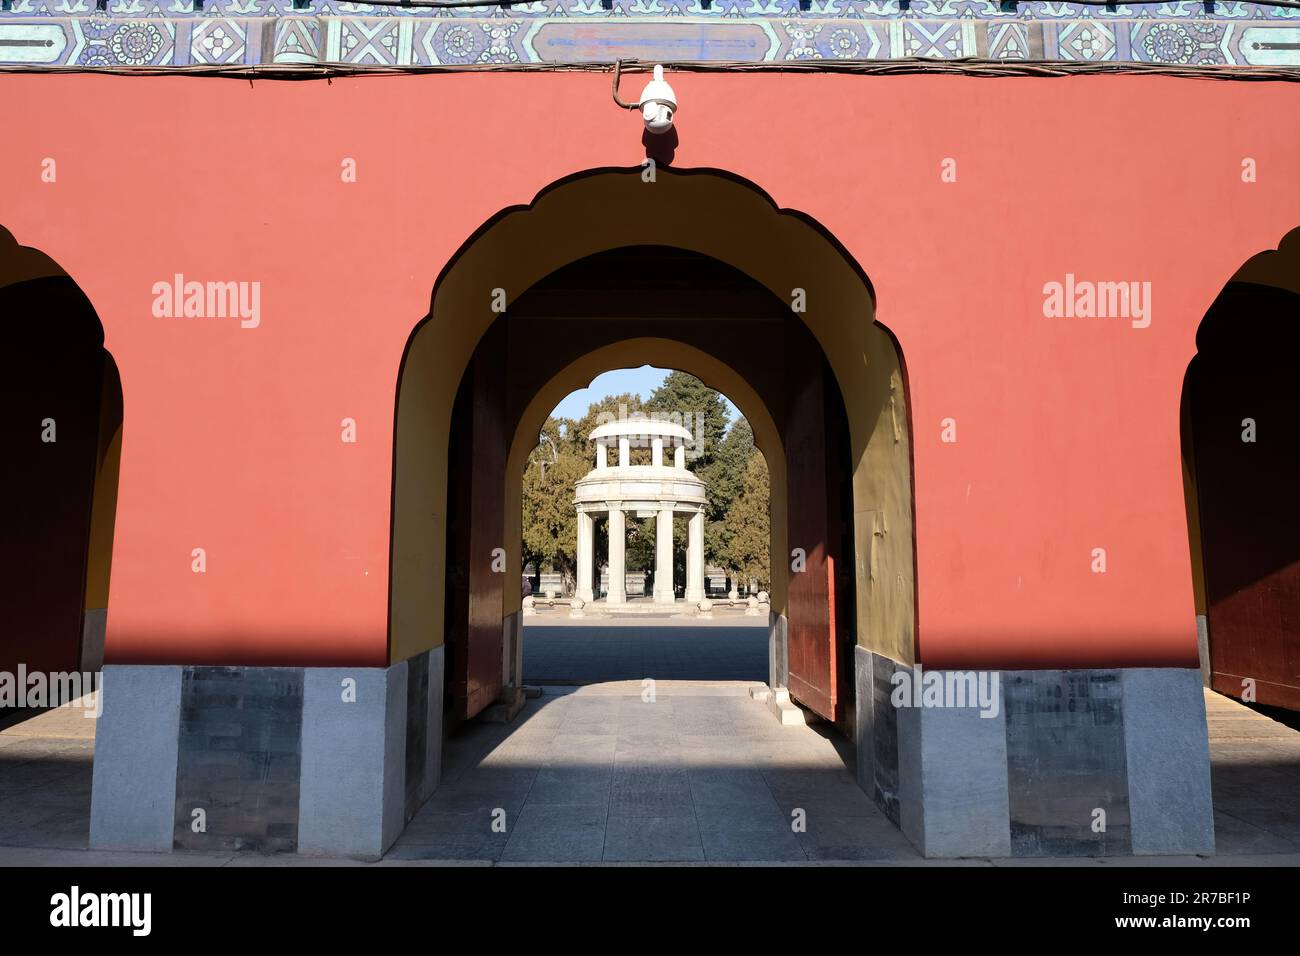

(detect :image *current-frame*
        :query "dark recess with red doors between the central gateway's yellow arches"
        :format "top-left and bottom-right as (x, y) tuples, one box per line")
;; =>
(445, 246), (855, 721)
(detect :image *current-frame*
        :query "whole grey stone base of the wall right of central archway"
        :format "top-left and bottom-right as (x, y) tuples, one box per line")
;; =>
(854, 648), (1214, 857)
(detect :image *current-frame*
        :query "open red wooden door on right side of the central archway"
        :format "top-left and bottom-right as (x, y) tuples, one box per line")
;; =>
(785, 321), (849, 721)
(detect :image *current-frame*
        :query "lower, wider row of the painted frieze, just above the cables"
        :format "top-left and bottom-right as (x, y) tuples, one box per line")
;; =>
(0, 10), (1300, 69)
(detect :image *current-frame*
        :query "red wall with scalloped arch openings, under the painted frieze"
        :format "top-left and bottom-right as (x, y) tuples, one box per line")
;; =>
(0, 73), (1300, 666)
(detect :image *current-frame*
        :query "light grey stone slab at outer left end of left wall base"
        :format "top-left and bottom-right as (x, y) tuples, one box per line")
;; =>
(90, 665), (185, 851)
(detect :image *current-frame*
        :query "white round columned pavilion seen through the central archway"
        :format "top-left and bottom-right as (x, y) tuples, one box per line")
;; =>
(573, 420), (709, 606)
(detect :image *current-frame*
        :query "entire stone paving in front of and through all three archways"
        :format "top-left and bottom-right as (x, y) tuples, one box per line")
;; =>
(0, 680), (1300, 866)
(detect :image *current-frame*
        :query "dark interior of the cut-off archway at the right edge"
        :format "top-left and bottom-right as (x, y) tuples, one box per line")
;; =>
(1183, 282), (1300, 709)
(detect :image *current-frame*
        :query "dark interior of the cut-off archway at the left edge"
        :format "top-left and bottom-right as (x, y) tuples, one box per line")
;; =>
(0, 276), (122, 697)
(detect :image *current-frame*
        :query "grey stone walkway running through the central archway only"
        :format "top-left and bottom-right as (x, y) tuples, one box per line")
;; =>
(390, 680), (918, 862)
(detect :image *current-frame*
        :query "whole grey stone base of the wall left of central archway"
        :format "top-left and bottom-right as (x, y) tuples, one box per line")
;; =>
(91, 648), (443, 860)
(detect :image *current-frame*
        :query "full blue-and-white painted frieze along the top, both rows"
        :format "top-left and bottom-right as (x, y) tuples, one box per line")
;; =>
(0, 0), (1300, 68)
